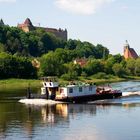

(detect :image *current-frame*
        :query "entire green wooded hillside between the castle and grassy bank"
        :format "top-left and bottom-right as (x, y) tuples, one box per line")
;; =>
(0, 25), (140, 80)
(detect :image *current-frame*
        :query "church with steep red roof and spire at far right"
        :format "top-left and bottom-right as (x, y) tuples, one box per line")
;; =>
(124, 41), (139, 59)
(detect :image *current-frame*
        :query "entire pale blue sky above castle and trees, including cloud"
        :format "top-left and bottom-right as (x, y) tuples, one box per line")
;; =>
(0, 0), (140, 55)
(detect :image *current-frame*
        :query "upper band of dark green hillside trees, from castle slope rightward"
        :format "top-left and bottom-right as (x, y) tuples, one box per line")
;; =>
(0, 26), (109, 58)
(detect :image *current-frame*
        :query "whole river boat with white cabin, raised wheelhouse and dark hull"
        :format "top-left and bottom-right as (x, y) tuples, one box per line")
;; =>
(28, 77), (122, 103)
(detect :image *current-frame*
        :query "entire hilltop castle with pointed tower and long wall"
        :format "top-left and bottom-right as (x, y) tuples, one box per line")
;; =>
(17, 18), (67, 40)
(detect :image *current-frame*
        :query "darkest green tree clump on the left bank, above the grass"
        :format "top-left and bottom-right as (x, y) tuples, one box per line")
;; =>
(0, 53), (36, 79)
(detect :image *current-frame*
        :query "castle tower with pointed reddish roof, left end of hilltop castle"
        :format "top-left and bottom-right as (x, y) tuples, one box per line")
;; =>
(18, 18), (34, 32)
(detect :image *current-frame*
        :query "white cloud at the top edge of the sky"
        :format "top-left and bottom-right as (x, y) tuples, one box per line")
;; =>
(55, 0), (114, 15)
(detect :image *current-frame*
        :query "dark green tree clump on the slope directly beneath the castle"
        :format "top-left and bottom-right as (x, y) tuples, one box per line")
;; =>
(0, 26), (65, 57)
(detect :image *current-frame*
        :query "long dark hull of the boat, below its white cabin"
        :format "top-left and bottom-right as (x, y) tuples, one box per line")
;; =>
(55, 92), (122, 103)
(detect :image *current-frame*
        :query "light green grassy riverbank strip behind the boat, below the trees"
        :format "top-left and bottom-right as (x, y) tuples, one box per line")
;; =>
(0, 76), (140, 92)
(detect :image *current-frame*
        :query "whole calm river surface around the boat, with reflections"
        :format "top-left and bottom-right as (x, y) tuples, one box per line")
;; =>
(0, 81), (140, 140)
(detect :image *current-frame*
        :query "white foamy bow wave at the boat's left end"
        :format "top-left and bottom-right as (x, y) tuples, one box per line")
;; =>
(19, 99), (62, 105)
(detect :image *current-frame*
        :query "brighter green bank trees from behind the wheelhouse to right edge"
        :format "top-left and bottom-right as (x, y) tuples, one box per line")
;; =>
(38, 49), (140, 80)
